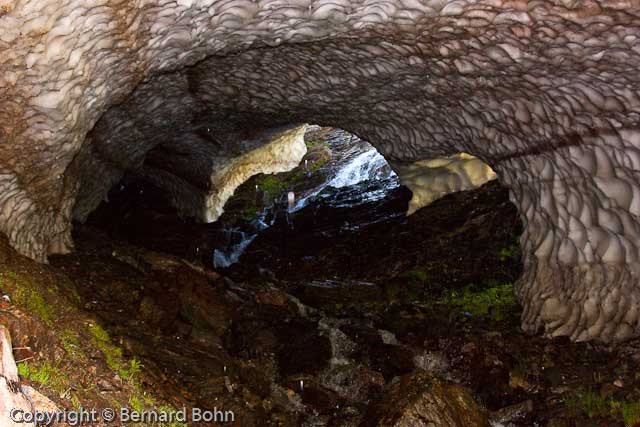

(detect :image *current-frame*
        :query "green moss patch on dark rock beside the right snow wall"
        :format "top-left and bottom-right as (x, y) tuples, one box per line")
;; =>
(440, 283), (515, 322)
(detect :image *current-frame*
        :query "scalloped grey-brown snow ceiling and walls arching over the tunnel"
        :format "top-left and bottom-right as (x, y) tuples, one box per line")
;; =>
(0, 0), (640, 341)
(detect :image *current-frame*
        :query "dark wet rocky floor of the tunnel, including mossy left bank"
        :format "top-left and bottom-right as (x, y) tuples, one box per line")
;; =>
(0, 132), (640, 427)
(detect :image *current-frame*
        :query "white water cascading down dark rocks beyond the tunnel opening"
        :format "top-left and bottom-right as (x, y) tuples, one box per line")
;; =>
(213, 129), (400, 268)
